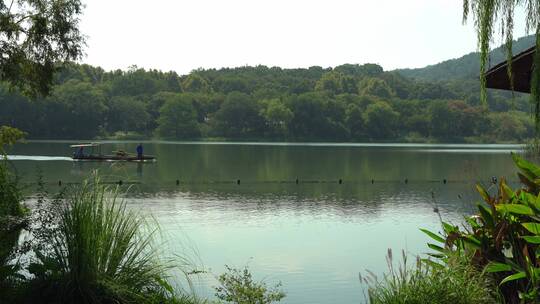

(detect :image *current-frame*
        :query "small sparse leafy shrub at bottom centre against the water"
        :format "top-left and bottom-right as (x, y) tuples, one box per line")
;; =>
(216, 265), (285, 304)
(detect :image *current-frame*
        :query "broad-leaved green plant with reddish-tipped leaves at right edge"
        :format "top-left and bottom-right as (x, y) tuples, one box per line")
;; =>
(422, 154), (540, 303)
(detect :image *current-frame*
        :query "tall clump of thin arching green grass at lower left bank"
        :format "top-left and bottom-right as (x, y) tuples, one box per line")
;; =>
(25, 178), (180, 303)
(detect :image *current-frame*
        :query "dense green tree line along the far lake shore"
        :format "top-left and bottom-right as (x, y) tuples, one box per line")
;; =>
(0, 64), (534, 142)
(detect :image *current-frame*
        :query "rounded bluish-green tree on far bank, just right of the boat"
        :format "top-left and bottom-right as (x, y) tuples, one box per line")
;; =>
(157, 94), (200, 139)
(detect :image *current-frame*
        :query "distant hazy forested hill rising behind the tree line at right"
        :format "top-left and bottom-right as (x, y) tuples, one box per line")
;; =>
(396, 35), (535, 81)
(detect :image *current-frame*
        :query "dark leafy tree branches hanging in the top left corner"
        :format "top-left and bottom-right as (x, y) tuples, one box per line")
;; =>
(0, 0), (84, 95)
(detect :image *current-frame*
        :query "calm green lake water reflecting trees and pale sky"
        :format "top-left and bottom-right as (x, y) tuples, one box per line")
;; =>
(9, 141), (519, 304)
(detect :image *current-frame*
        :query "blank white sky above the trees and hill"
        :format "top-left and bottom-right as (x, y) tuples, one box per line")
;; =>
(81, 0), (524, 74)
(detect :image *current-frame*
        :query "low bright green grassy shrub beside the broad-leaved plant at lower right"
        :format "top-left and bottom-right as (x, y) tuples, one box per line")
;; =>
(362, 251), (496, 304)
